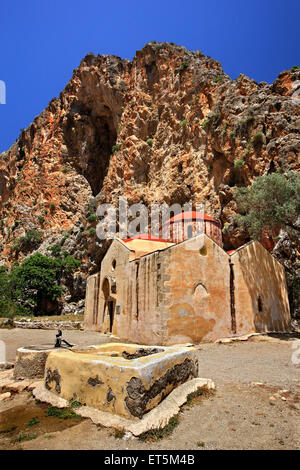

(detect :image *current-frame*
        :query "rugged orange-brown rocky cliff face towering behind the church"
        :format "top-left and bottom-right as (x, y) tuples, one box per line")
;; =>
(0, 43), (300, 314)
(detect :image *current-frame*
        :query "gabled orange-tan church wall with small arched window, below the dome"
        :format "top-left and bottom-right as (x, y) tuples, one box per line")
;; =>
(164, 235), (231, 344)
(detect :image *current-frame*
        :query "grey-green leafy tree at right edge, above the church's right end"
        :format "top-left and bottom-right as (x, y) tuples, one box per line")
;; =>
(234, 171), (300, 239)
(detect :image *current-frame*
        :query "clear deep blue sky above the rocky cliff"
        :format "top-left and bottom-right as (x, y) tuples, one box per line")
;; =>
(0, 0), (300, 151)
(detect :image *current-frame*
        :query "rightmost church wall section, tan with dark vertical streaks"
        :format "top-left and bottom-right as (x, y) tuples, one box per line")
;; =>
(231, 242), (290, 334)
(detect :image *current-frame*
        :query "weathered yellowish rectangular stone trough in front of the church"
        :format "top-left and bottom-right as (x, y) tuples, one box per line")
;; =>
(45, 343), (198, 418)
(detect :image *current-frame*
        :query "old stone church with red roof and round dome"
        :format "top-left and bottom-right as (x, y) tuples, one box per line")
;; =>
(85, 211), (290, 345)
